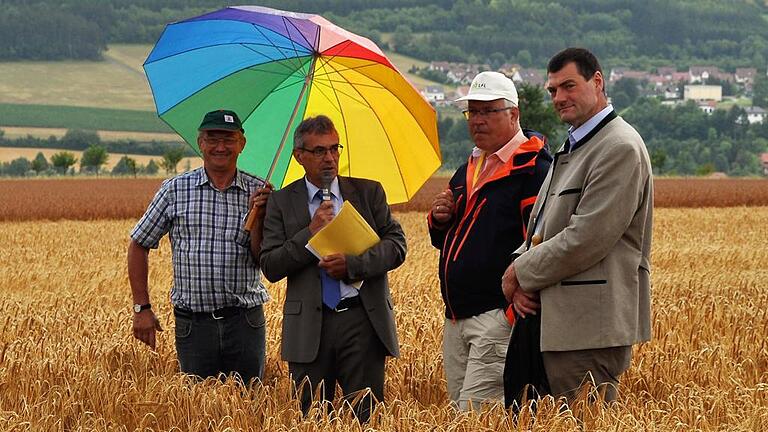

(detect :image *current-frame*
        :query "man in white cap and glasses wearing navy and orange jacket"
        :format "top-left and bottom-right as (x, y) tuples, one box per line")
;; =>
(427, 72), (552, 410)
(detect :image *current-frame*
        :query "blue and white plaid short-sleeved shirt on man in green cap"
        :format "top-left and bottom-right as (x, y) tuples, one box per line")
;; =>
(131, 168), (269, 312)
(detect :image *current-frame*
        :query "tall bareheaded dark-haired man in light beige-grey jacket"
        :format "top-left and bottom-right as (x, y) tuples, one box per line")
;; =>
(502, 48), (653, 401)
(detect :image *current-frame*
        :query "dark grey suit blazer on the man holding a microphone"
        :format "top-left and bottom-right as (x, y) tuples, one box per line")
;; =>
(260, 176), (406, 363)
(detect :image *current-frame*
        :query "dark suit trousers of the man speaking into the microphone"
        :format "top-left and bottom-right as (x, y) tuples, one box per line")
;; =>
(288, 306), (386, 422)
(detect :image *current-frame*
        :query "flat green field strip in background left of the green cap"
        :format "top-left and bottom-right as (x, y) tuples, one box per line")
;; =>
(0, 103), (173, 132)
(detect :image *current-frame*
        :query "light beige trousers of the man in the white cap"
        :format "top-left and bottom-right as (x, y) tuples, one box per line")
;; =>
(443, 309), (512, 411)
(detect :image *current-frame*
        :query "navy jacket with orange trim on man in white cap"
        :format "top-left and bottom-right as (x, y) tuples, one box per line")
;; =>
(427, 130), (552, 319)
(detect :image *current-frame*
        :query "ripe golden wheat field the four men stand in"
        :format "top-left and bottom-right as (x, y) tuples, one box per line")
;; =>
(0, 207), (768, 431)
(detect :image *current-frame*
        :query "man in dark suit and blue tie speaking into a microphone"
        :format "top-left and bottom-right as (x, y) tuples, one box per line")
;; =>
(261, 115), (406, 422)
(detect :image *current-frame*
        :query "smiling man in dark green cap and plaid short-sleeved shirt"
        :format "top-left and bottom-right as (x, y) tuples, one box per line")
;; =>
(128, 110), (272, 383)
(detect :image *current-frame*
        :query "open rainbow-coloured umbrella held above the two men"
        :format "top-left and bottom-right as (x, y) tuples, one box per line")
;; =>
(144, 6), (441, 203)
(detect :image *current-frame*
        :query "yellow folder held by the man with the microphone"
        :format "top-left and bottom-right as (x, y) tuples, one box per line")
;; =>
(306, 201), (381, 258)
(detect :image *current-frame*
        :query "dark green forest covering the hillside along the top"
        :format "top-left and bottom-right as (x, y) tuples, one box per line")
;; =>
(0, 0), (768, 70)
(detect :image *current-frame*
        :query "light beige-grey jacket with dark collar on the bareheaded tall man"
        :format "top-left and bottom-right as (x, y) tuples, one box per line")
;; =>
(515, 117), (653, 351)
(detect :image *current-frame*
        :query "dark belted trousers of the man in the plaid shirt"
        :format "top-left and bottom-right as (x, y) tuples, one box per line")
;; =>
(174, 306), (266, 384)
